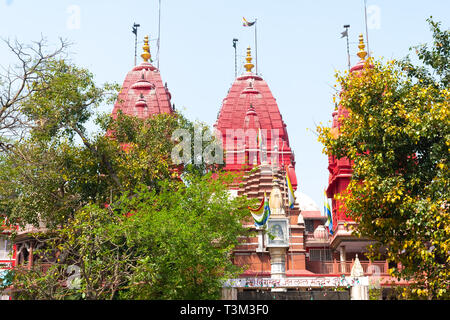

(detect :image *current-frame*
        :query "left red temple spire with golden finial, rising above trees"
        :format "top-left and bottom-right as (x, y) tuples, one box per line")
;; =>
(112, 36), (173, 119)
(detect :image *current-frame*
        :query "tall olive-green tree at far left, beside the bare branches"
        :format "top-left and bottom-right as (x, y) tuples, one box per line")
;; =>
(0, 59), (116, 227)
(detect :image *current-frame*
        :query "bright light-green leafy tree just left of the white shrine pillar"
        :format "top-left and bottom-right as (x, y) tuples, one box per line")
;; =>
(121, 175), (248, 299)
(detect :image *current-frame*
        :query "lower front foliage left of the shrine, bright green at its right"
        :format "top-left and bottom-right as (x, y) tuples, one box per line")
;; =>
(9, 175), (247, 299)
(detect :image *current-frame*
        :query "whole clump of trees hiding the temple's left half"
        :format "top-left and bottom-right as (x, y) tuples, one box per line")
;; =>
(0, 38), (247, 299)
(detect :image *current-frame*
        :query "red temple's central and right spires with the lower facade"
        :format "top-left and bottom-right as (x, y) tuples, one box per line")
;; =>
(220, 35), (400, 299)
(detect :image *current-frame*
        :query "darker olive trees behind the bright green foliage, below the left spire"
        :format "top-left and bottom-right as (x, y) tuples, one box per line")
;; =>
(0, 55), (207, 228)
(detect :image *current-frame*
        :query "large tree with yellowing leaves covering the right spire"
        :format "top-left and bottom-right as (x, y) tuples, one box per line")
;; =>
(318, 19), (450, 299)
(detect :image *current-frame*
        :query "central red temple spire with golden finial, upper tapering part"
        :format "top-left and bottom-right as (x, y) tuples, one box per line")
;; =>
(214, 49), (297, 188)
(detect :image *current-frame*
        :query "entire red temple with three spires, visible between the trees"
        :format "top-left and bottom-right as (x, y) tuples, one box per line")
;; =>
(0, 32), (404, 299)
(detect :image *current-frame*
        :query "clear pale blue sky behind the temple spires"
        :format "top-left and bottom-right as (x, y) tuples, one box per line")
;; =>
(0, 0), (450, 208)
